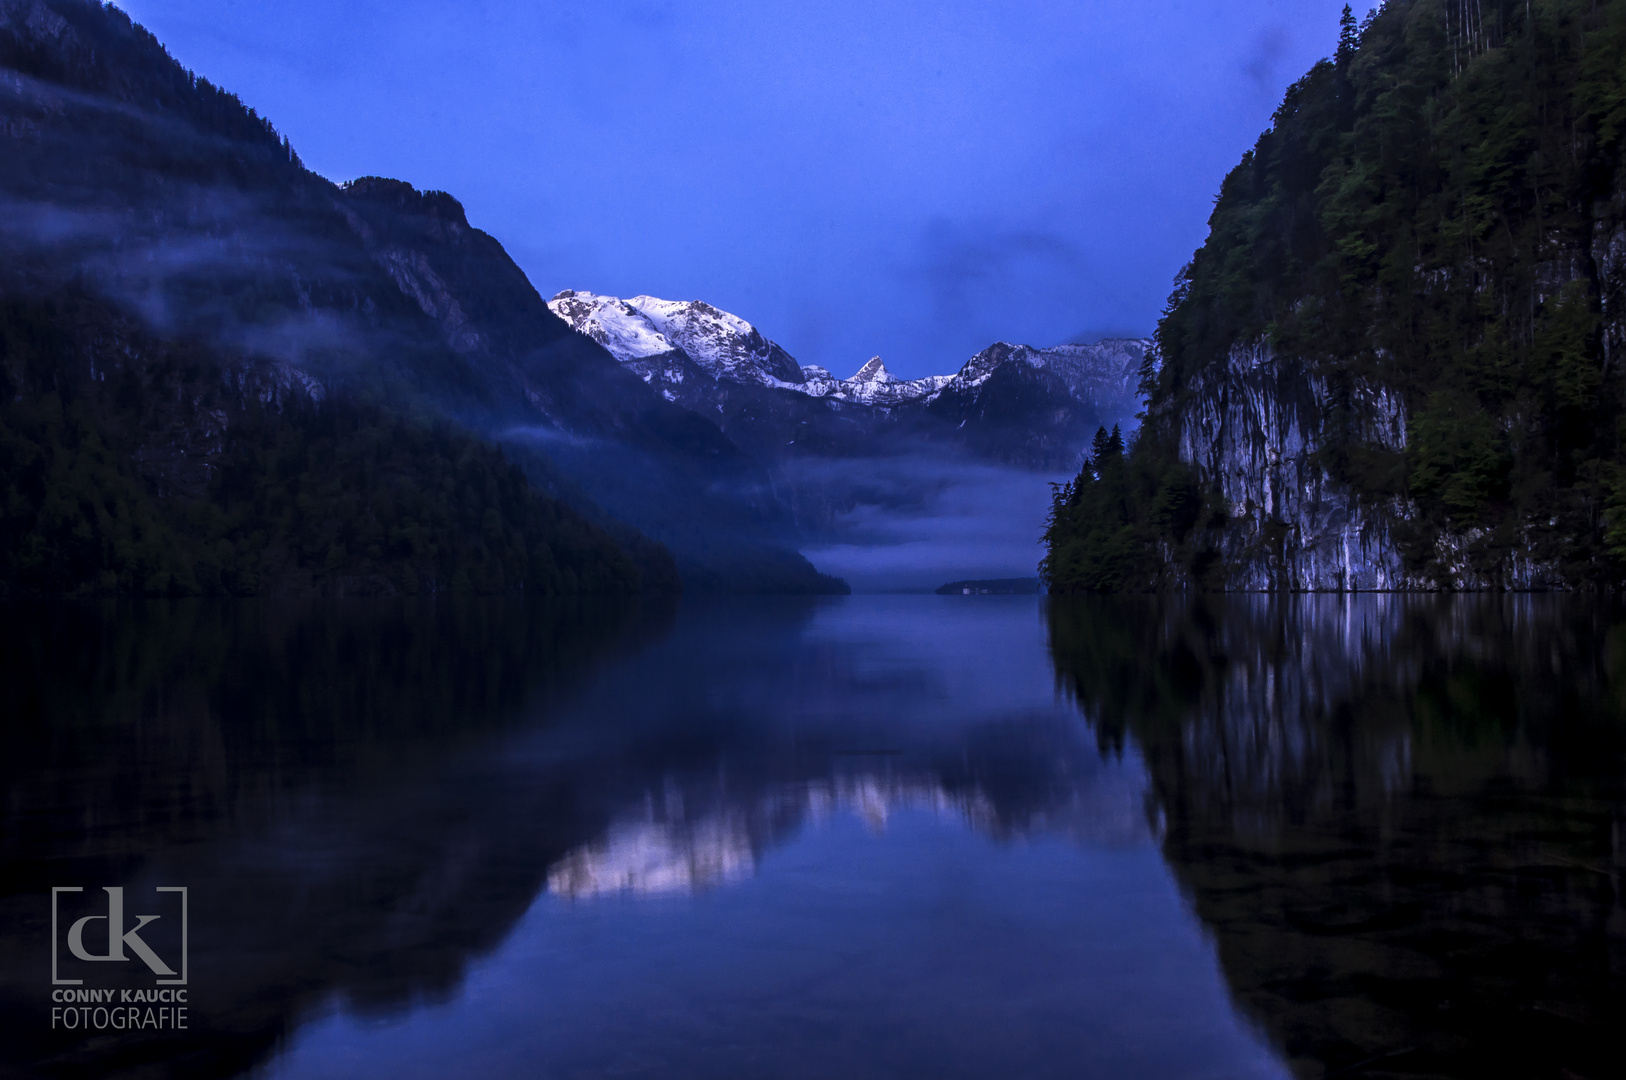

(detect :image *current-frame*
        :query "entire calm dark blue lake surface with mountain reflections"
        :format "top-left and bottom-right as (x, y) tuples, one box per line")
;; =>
(0, 595), (1626, 1080)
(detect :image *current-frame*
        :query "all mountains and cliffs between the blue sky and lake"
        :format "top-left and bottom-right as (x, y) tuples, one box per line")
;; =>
(0, 0), (1626, 595)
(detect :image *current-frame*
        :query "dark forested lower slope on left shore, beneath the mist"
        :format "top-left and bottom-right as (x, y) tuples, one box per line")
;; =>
(0, 289), (660, 595)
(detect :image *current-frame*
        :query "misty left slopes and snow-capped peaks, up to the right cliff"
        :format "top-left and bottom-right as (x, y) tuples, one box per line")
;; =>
(0, 0), (1148, 595)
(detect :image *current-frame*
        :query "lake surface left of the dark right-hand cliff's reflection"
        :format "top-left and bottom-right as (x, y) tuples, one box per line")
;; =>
(0, 597), (1280, 1078)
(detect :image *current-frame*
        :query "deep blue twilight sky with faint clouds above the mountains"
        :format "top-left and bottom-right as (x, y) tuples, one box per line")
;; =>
(122, 0), (1341, 376)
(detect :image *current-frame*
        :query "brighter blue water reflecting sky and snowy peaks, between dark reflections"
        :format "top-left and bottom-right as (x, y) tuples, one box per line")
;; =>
(268, 597), (1285, 1080)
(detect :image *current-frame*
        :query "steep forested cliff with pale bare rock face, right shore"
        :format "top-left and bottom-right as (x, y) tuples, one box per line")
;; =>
(1047, 0), (1626, 590)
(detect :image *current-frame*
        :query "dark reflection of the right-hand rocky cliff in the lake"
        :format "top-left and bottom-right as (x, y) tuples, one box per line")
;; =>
(1050, 595), (1626, 1077)
